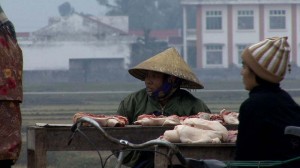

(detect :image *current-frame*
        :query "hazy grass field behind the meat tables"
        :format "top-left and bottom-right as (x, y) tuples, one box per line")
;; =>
(14, 80), (300, 168)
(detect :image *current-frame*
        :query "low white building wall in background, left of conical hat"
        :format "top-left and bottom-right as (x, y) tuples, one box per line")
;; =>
(21, 42), (130, 70)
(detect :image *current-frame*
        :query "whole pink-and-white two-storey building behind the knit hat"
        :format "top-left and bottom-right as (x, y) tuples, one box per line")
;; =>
(181, 0), (300, 68)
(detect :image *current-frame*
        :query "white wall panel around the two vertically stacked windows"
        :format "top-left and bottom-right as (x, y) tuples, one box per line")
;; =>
(201, 5), (228, 68)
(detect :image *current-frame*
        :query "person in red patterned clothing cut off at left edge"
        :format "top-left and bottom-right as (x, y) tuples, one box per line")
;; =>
(0, 6), (23, 168)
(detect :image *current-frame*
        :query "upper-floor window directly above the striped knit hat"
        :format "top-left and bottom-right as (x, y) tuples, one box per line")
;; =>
(270, 10), (286, 29)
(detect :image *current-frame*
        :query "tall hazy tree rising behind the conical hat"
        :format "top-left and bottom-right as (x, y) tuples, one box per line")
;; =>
(97, 0), (182, 66)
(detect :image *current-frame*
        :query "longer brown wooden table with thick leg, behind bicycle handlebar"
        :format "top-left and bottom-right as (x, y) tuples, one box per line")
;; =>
(27, 125), (173, 168)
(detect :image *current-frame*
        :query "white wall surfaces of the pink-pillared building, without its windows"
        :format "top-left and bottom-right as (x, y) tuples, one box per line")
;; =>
(181, 0), (300, 68)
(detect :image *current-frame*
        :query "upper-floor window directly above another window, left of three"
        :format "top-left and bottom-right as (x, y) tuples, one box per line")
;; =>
(206, 11), (222, 30)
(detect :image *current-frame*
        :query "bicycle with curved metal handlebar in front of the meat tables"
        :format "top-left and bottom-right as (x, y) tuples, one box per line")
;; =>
(68, 117), (300, 168)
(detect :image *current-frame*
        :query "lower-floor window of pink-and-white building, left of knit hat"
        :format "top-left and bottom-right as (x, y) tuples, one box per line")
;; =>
(206, 44), (223, 65)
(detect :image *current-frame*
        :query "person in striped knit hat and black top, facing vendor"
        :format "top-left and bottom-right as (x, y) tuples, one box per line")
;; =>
(235, 37), (300, 167)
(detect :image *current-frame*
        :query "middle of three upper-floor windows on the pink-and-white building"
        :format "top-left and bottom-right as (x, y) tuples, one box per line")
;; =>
(238, 10), (254, 30)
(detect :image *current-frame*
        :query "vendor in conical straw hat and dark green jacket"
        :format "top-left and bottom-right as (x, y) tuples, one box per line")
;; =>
(117, 48), (210, 168)
